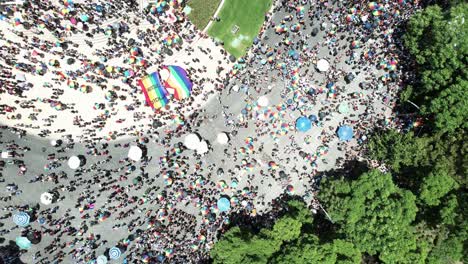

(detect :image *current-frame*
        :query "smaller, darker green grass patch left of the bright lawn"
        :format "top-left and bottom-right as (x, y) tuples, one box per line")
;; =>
(187, 0), (221, 30)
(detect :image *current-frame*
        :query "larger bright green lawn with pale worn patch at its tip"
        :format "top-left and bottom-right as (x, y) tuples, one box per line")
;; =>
(208, 0), (272, 58)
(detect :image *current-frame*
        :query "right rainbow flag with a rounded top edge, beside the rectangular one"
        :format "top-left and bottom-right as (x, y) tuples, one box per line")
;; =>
(164, 65), (193, 100)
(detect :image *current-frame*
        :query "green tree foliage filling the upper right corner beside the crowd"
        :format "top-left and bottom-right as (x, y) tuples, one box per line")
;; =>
(404, 2), (468, 132)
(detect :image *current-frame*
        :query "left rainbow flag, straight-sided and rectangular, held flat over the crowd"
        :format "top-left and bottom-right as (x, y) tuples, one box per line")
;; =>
(138, 72), (169, 109)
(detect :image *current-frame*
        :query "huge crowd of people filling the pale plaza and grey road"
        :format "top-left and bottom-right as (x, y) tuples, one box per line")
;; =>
(0, 0), (418, 263)
